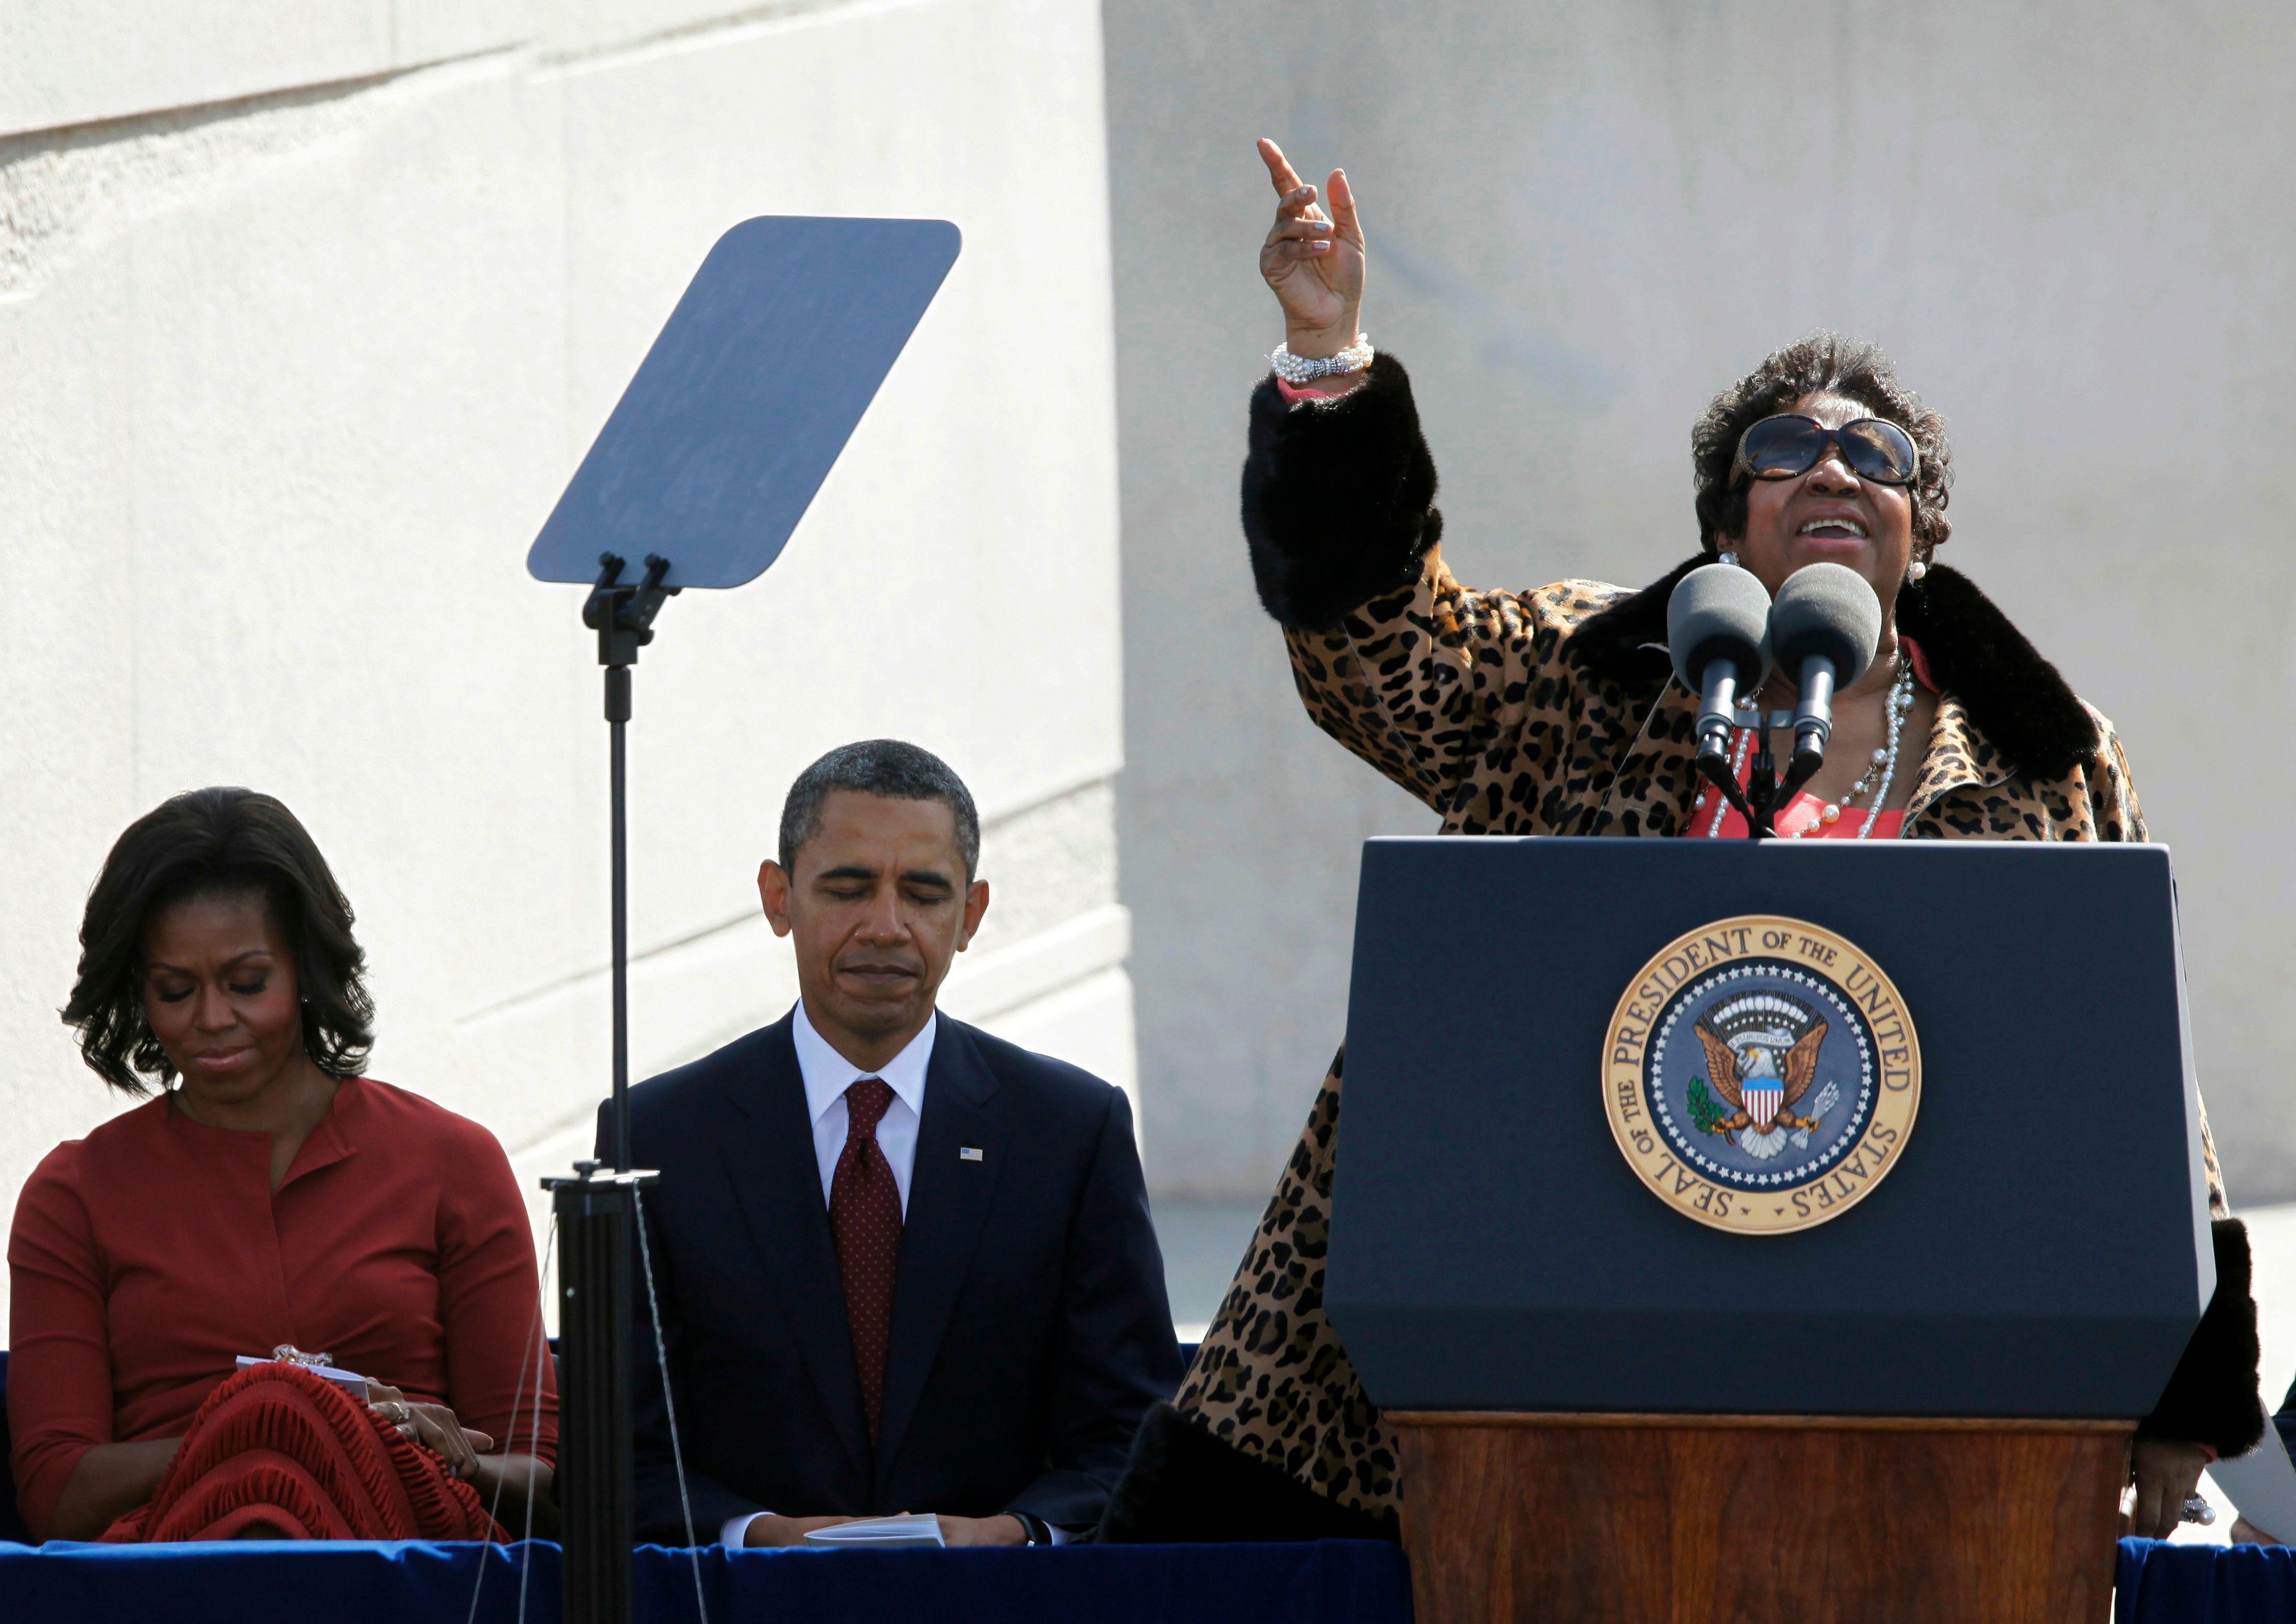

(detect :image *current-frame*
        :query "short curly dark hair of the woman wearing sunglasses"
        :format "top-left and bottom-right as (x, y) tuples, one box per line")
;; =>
(1690, 333), (1954, 563)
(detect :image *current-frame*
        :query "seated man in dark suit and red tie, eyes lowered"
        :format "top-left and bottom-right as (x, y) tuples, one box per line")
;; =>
(602, 740), (1180, 1546)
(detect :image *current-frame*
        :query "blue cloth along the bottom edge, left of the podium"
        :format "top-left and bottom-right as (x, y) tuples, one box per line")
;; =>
(0, 1539), (1412, 1624)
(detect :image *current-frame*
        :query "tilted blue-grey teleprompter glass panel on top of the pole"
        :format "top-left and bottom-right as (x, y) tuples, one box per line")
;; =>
(526, 216), (960, 588)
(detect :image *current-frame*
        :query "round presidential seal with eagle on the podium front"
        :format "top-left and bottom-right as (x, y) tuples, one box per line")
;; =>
(1602, 914), (1922, 1236)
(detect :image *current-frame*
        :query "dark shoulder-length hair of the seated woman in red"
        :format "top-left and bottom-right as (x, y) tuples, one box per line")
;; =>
(64, 788), (374, 1094)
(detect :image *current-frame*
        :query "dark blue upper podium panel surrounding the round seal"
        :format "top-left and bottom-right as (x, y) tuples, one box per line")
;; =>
(1325, 839), (2216, 1417)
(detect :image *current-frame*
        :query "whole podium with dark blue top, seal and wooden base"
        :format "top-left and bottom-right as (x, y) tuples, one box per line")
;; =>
(1325, 839), (2216, 1624)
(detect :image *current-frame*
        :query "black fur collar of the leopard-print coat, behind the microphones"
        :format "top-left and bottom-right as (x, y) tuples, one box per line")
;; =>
(1571, 553), (2096, 779)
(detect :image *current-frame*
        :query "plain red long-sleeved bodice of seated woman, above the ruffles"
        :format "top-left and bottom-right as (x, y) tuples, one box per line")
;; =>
(7, 1077), (558, 1539)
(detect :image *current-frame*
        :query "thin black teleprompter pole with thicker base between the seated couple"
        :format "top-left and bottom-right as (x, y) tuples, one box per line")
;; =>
(542, 553), (677, 1624)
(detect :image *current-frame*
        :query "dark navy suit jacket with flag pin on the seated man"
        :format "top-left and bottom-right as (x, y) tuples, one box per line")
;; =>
(599, 1015), (1180, 1544)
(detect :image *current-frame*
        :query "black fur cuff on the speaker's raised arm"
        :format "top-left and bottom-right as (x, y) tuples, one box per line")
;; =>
(1244, 354), (1442, 632)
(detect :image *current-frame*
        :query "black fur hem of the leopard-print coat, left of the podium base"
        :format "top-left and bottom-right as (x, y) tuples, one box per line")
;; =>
(1095, 1403), (1403, 1546)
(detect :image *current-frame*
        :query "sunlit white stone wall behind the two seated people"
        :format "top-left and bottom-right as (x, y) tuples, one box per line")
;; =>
(0, 0), (1132, 1332)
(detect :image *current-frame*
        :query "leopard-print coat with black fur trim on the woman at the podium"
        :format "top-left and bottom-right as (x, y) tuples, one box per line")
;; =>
(1175, 356), (2225, 1518)
